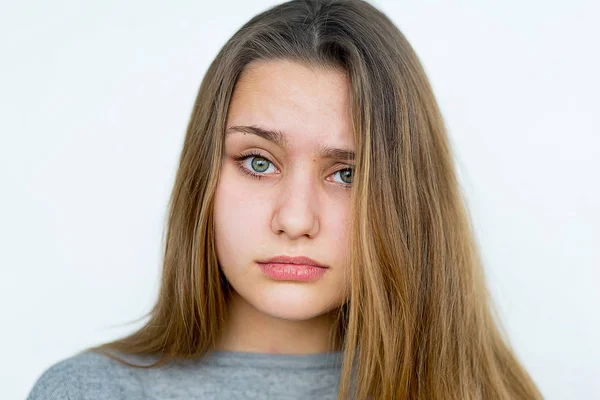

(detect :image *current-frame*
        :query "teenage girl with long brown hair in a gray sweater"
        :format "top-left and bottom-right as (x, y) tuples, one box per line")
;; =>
(29, 0), (541, 400)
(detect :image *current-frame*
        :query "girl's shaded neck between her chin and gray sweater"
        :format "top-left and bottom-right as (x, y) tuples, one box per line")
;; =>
(216, 291), (340, 354)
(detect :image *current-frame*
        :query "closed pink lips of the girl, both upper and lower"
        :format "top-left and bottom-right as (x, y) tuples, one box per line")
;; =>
(258, 256), (328, 281)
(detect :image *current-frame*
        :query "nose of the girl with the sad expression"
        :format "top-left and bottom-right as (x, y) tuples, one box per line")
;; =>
(271, 171), (319, 239)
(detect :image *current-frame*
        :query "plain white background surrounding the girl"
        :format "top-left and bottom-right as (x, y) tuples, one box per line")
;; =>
(0, 0), (600, 399)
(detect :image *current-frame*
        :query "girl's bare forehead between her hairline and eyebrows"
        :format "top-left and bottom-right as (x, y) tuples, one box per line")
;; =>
(226, 60), (352, 151)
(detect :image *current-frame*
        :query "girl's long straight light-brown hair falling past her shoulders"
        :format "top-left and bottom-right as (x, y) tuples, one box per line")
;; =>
(88, 0), (541, 399)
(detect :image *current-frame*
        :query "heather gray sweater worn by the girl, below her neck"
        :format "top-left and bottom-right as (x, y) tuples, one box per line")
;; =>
(27, 351), (343, 400)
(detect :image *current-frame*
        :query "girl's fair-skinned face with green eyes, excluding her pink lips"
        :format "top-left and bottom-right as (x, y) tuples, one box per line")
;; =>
(214, 60), (355, 320)
